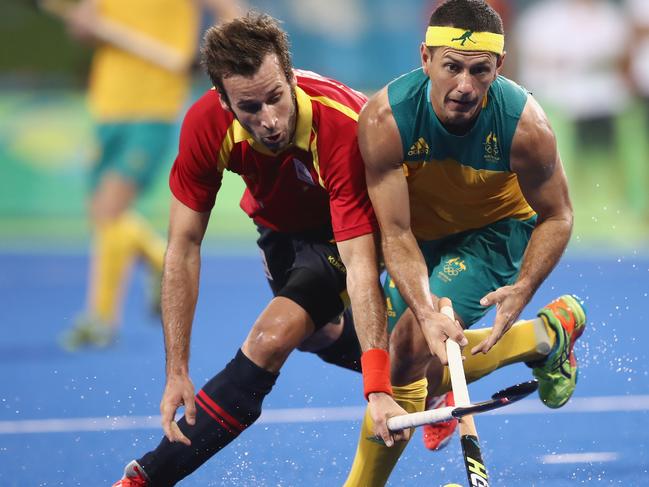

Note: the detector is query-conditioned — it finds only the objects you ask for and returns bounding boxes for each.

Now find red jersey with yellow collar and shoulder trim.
[170,70,377,241]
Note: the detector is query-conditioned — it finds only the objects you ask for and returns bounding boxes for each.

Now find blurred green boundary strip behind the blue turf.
[0,90,649,253]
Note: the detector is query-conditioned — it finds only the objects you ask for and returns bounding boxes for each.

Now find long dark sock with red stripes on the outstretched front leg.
[138,350,279,487]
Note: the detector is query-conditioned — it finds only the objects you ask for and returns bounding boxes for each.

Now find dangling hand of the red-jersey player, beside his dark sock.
[160,374,196,446]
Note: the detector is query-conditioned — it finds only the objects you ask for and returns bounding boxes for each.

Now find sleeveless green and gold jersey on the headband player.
[388,68,535,240]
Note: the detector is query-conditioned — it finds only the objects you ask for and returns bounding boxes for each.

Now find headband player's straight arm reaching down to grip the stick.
[358,88,465,363]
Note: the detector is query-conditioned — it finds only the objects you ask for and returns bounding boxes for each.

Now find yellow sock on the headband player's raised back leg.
[433,318,556,396]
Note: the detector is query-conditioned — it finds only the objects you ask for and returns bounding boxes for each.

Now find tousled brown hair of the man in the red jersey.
[201,12,293,103]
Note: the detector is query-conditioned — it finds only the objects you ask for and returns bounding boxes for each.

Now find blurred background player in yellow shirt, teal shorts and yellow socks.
[59,0,240,350]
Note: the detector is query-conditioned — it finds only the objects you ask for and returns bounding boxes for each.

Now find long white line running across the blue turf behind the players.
[0,395,649,435]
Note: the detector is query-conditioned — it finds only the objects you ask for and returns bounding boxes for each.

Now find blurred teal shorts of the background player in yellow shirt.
[90,121,175,190]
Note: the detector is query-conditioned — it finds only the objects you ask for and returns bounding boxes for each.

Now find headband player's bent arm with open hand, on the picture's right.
[472,96,573,353]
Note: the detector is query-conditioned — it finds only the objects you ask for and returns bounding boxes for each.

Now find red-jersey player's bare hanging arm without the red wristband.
[160,197,209,444]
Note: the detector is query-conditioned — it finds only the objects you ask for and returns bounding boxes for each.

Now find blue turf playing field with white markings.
[0,253,649,487]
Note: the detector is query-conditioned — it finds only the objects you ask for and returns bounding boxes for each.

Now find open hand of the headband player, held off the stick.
[471,285,530,355]
